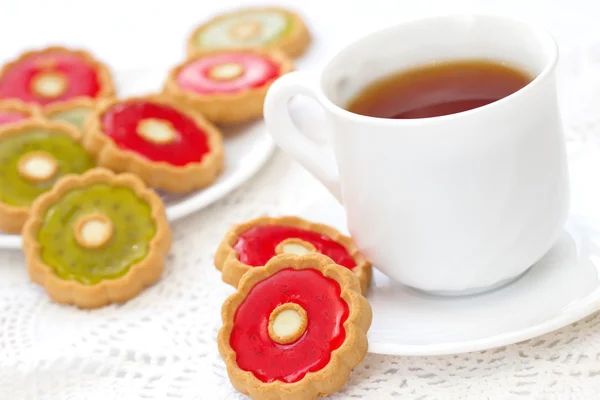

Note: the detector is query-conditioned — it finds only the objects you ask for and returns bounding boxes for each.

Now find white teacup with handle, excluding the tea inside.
[265,16,568,294]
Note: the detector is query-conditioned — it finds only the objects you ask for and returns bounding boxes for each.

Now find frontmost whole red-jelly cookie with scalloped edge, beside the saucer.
[218,253,372,400]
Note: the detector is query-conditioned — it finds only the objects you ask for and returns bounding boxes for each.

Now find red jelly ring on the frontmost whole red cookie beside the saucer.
[230,269,349,383]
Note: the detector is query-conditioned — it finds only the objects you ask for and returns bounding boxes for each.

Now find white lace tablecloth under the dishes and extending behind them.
[0,0,600,400]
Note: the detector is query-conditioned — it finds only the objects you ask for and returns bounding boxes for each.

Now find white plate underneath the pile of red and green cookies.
[0,69,275,249]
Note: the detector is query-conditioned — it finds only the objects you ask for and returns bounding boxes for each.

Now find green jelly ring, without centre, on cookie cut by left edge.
[0,130,94,207]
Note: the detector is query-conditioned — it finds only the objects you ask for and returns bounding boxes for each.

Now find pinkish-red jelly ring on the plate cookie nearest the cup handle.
[176,52,280,94]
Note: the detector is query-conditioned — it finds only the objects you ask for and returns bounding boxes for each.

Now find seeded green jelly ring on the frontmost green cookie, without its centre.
[37,184,156,285]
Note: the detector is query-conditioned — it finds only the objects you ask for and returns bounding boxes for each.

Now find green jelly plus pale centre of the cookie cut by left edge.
[0,128,94,207]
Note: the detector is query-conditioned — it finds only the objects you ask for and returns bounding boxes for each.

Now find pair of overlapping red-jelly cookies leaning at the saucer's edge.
[215,216,372,400]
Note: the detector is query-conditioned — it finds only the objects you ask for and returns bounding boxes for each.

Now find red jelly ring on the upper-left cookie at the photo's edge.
[0,51,100,105]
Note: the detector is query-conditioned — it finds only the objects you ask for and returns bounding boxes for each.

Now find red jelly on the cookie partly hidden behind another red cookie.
[234,225,356,269]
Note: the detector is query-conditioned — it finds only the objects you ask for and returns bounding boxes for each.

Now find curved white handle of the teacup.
[264,72,342,203]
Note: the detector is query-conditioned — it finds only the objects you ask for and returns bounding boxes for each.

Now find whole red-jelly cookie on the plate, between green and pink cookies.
[83,96,224,193]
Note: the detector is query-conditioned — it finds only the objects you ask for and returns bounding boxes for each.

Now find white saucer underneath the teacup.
[301,192,600,355]
